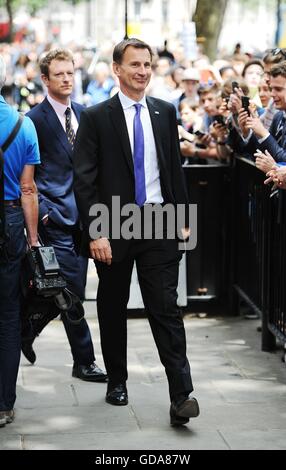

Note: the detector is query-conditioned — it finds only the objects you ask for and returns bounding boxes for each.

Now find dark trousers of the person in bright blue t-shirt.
[0,207,26,411]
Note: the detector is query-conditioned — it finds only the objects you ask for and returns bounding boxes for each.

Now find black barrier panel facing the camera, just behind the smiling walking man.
[183,162,232,313]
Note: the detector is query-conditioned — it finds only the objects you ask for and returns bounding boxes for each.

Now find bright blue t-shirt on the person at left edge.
[0,95,41,201]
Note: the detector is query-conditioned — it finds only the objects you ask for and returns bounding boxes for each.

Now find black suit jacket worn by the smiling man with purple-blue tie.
[74,95,188,260]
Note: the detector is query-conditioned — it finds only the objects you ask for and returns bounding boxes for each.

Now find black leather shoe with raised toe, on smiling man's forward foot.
[170,396,200,426]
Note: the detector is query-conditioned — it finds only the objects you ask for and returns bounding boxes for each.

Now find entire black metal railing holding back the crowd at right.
[184,157,286,351]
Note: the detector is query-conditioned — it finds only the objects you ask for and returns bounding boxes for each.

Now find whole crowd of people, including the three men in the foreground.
[0,35,286,427]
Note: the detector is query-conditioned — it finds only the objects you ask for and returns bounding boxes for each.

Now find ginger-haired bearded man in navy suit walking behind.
[22,49,107,382]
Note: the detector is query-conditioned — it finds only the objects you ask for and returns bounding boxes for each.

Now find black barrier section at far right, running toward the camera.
[232,157,286,351]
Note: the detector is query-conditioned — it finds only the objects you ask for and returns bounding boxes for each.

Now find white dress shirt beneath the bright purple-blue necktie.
[118,90,163,204]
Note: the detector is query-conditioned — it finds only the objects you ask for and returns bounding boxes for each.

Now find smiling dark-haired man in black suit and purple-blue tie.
[74,39,199,425]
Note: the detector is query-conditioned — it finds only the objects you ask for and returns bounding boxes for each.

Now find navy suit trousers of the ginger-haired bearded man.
[39,220,95,365]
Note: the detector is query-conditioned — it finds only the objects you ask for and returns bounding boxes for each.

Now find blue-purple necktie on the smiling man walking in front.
[133,103,146,207]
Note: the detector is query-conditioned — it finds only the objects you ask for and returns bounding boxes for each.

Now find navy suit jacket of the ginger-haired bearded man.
[27,98,84,226]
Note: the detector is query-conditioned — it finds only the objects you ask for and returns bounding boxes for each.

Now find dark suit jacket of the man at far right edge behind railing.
[244,111,286,162]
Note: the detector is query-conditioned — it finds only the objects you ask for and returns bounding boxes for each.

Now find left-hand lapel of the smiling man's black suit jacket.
[108,95,134,175]
